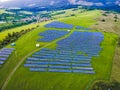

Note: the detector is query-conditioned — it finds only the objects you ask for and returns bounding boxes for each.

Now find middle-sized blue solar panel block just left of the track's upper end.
[37,30,68,42]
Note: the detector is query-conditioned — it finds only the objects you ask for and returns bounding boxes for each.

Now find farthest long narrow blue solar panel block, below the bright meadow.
[45,21,73,29]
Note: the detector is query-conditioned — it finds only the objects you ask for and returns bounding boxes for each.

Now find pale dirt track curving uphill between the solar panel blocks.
[1,29,74,90]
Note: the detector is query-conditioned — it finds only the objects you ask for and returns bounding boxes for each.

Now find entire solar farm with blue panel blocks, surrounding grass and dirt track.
[0,10,117,90]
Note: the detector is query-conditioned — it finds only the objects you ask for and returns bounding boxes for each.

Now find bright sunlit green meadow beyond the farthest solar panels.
[59,10,101,27]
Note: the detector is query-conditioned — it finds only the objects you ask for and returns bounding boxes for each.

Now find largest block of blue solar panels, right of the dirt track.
[24,31,104,74]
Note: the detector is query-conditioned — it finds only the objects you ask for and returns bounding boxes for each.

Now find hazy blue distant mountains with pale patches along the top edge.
[0,0,120,9]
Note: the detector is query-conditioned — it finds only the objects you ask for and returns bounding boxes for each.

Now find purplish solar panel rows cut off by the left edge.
[0,48,14,65]
